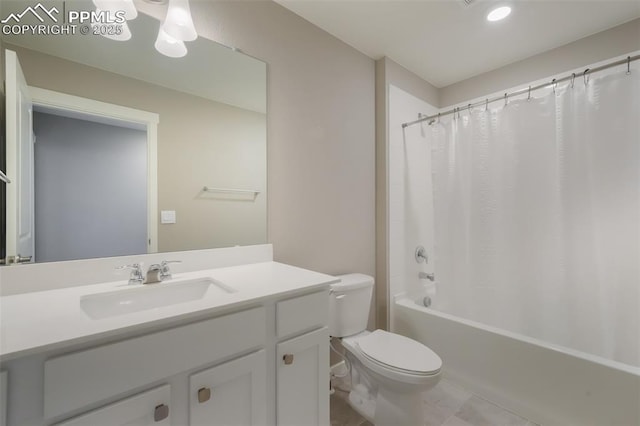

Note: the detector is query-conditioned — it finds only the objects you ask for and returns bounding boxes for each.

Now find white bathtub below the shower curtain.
[391,297,640,426]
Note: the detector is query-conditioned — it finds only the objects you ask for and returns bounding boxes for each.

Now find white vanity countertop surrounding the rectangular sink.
[0,262,339,361]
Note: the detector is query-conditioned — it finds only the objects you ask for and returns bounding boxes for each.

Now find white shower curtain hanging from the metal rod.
[429,66,640,366]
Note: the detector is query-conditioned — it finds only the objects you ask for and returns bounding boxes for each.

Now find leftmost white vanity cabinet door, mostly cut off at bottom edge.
[57,385,171,426]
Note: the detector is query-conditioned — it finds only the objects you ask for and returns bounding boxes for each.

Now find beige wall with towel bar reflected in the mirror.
[7,45,267,251]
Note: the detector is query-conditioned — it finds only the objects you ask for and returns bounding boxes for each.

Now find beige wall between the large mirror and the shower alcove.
[182,0,375,282]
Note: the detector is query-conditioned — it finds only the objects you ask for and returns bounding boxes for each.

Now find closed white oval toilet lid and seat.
[354,330,442,376]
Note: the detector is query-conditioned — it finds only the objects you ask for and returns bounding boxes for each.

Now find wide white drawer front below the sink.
[44,308,266,418]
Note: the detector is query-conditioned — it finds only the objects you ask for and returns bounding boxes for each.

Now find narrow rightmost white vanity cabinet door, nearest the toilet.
[276,327,329,426]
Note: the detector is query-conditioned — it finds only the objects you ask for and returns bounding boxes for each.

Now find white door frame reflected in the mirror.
[29,86,160,253]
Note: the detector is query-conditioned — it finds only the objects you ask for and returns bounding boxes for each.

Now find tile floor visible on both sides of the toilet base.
[331,379,537,426]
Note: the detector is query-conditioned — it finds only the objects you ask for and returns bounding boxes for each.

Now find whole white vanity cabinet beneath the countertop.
[0,287,329,426]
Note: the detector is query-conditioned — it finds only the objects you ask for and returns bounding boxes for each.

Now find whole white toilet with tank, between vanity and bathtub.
[329,274,442,426]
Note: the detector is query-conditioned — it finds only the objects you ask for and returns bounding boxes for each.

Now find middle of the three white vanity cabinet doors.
[189,350,267,426]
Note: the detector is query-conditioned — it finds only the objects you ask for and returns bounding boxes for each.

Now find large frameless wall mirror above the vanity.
[0,0,267,263]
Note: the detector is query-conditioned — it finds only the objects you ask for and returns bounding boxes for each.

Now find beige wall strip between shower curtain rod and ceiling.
[440,19,640,108]
